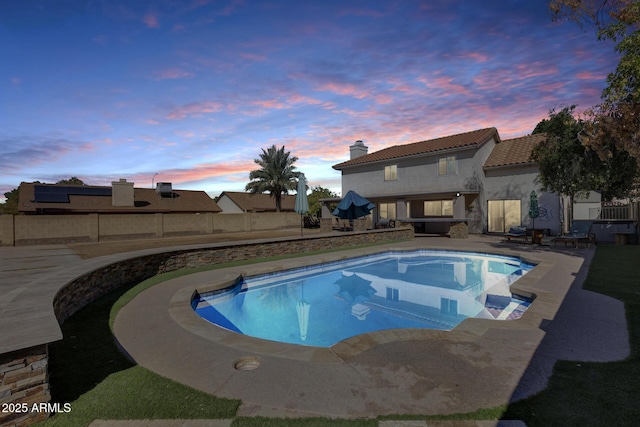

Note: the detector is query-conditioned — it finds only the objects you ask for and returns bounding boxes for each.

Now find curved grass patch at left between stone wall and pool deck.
[41,282,240,427]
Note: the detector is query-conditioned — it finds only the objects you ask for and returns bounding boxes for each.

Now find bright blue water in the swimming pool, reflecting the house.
[193,250,533,347]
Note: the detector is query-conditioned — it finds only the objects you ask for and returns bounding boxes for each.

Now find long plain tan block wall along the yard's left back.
[0,212,300,246]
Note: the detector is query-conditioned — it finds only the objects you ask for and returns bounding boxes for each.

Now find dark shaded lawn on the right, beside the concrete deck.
[503,245,640,427]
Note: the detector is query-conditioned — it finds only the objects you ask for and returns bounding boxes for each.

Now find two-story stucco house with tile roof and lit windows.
[333,128,560,234]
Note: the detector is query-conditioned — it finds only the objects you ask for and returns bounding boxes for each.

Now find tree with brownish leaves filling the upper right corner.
[549,0,640,164]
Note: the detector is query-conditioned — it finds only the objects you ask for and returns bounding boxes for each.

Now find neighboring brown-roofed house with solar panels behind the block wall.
[18,179,221,215]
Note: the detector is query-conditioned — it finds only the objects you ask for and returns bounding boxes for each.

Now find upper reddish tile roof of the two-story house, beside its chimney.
[333,127,500,170]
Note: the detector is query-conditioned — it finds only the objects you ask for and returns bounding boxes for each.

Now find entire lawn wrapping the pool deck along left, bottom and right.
[43,245,640,427]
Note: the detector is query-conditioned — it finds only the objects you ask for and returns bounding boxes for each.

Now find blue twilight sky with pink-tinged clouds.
[0,0,617,201]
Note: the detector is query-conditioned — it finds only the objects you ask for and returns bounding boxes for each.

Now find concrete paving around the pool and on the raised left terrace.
[0,230,629,425]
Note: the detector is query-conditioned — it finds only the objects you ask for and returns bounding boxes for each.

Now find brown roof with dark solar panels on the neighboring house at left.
[18,182,222,213]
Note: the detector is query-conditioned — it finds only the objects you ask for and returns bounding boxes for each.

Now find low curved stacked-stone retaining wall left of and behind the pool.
[0,226,414,426]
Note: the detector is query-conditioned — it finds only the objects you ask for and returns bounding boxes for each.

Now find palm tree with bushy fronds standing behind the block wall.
[245,145,300,212]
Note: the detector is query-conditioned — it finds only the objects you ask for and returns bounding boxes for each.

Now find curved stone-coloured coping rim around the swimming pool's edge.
[168,245,552,363]
